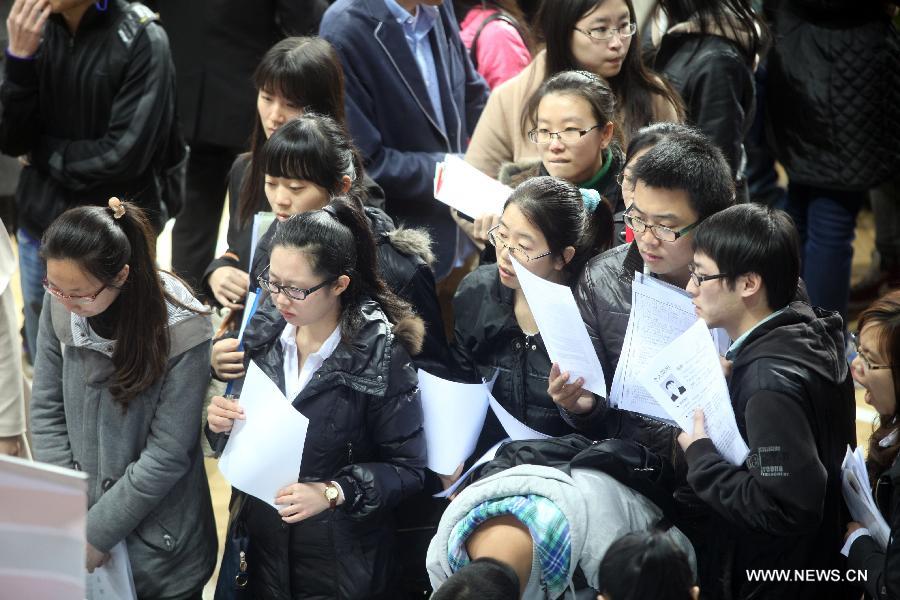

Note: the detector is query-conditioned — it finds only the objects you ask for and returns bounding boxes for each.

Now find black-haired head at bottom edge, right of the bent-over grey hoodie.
[598,531,694,600]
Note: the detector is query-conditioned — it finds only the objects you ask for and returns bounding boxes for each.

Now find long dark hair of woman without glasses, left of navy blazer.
[238,37,346,224]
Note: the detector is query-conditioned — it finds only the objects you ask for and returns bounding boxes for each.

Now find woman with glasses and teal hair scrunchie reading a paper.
[451,177,612,482]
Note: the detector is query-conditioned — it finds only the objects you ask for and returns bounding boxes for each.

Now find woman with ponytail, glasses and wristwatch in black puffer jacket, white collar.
[207,198,425,599]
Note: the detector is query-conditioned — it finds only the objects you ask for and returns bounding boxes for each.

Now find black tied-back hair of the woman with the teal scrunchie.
[503,176,613,285]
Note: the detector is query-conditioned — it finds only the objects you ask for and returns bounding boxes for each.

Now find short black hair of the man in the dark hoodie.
[694,204,800,310]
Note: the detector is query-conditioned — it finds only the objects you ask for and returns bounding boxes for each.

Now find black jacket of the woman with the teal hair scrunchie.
[451,264,603,457]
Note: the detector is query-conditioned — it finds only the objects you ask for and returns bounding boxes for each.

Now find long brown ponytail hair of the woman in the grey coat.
[41,202,194,405]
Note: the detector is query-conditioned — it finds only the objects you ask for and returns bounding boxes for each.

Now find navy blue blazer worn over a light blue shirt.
[319,0,488,279]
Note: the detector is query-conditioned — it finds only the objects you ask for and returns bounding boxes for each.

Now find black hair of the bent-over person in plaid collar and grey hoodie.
[431,558,519,600]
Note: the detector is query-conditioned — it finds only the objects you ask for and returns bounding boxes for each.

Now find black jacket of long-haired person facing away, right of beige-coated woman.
[654,12,756,179]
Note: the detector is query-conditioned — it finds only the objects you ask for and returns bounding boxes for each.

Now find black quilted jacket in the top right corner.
[766,0,900,190]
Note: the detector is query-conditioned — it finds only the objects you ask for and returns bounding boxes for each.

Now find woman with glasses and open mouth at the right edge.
[844,291,900,600]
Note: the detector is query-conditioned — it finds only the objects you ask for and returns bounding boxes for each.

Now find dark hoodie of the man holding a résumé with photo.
[685,302,858,600]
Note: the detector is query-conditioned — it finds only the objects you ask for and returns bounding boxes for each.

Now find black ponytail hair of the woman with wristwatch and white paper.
[272,197,415,346]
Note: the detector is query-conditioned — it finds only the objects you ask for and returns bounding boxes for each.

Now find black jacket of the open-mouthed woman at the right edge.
[847,458,900,600]
